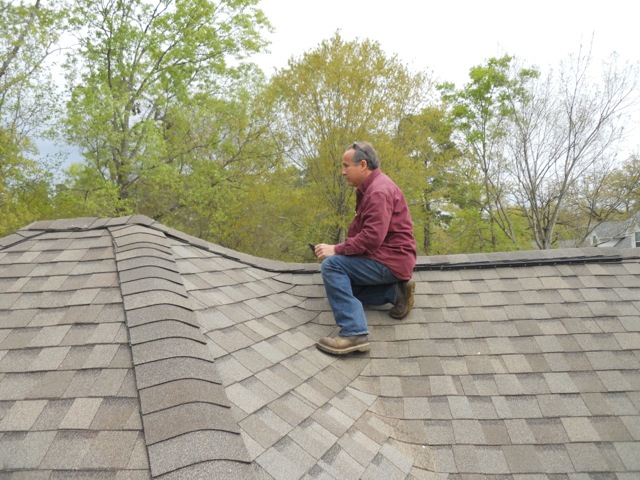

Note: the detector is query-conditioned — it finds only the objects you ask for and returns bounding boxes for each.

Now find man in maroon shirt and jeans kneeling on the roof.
[314,142,416,355]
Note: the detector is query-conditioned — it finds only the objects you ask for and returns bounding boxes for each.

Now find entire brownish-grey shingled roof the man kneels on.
[0,216,640,480]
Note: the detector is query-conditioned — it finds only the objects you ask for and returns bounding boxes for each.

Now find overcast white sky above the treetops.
[254,0,640,149]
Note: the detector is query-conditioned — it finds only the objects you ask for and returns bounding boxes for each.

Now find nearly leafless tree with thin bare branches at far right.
[508,50,638,249]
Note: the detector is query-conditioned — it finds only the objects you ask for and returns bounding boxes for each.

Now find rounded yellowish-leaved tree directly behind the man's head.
[272,33,427,243]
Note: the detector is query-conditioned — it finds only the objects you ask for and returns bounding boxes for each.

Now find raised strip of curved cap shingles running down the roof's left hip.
[107,220,250,477]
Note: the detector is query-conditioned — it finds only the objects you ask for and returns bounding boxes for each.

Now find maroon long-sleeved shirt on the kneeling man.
[335,168,416,280]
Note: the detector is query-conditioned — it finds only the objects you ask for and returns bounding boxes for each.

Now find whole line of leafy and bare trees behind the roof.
[0,0,640,262]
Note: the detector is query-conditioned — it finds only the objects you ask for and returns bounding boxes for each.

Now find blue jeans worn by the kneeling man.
[320,255,400,337]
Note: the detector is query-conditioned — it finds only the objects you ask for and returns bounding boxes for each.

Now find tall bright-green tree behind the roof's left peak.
[66,0,268,216]
